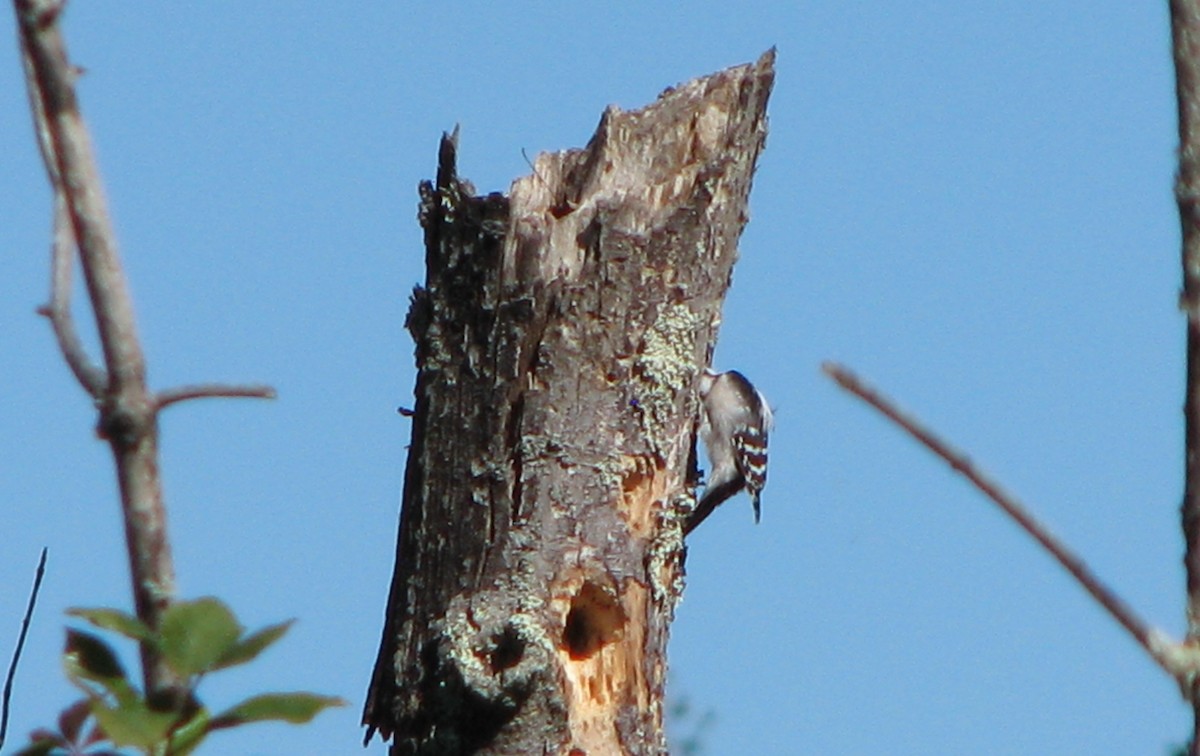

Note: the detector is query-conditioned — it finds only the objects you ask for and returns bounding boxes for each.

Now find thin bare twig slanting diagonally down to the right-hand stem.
[821,362,1183,679]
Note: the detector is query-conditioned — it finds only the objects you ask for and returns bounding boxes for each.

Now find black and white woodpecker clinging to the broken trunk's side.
[683,370,774,535]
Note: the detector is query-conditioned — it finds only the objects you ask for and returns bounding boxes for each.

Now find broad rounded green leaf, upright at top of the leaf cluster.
[158,598,242,677]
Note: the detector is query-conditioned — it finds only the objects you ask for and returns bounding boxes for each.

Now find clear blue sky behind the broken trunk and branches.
[0,0,1190,754]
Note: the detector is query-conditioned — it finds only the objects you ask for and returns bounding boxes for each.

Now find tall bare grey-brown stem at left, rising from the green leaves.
[13,0,179,694]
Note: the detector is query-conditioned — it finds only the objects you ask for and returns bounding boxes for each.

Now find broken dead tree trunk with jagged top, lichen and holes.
[364,52,774,754]
